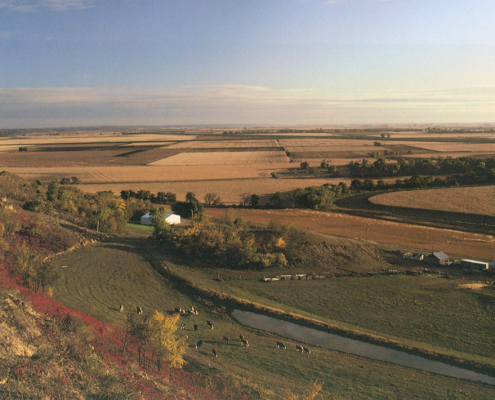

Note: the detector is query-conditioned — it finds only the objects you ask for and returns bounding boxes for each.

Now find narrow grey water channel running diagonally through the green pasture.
[232,310,495,385]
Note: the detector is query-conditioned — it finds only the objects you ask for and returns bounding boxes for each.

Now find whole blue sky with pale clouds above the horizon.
[0,0,495,129]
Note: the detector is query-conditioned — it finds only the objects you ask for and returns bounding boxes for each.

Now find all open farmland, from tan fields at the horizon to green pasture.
[4,124,495,399]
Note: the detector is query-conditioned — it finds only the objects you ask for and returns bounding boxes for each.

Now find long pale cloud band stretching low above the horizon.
[0,85,495,127]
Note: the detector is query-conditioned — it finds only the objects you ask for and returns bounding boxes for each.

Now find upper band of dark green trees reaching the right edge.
[346,157,495,178]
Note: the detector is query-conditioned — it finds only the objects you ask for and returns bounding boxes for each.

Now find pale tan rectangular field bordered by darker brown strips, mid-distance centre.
[149,151,289,166]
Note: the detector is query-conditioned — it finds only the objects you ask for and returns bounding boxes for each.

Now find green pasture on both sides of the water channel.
[54,237,494,399]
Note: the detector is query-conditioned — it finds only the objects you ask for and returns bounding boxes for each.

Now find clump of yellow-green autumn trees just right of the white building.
[153,210,288,269]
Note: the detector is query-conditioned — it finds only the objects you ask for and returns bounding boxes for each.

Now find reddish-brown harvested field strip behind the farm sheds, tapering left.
[206,209,495,260]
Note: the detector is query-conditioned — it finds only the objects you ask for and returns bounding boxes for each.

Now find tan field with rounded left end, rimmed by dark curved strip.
[369,186,495,216]
